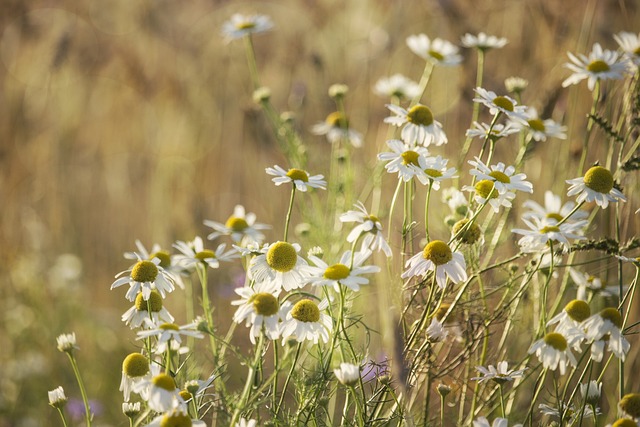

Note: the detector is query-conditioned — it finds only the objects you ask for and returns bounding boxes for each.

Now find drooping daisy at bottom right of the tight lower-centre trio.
[280,299,333,345]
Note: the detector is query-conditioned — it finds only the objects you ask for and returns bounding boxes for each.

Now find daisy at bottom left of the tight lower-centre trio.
[231,281,283,344]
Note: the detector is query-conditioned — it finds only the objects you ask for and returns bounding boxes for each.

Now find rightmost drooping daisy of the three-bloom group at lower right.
[582,307,631,362]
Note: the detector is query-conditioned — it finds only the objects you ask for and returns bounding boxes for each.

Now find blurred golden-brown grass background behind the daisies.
[0,0,640,427]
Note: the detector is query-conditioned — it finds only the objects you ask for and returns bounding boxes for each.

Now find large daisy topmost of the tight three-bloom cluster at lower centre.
[249,242,309,292]
